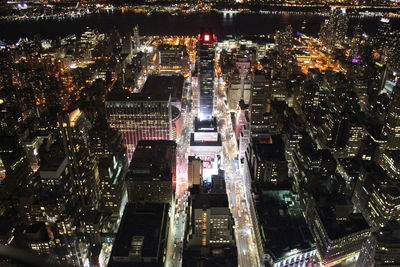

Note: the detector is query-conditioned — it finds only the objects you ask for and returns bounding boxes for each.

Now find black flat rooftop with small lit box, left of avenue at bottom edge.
[107,203,169,267]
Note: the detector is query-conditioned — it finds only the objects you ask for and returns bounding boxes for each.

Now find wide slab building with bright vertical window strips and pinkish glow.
[106,76,183,160]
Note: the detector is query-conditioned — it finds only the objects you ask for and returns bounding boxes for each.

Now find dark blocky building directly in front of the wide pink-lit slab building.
[126,140,176,203]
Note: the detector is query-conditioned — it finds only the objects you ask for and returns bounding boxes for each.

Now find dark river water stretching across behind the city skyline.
[0,11,400,42]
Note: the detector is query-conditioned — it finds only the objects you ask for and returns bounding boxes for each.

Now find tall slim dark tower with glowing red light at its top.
[197,30,216,120]
